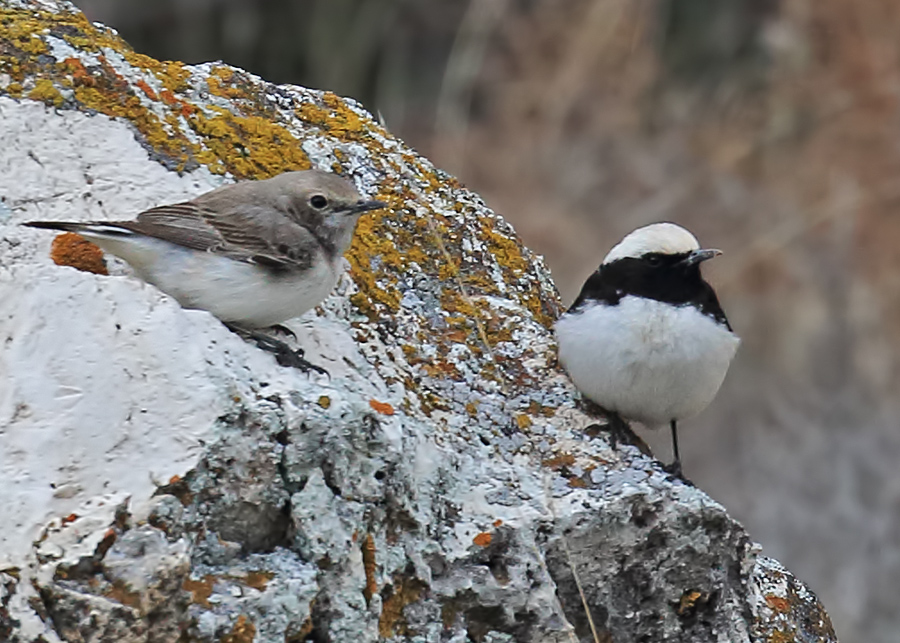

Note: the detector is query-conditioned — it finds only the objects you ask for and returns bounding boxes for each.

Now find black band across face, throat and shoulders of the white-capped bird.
[568,253,731,330]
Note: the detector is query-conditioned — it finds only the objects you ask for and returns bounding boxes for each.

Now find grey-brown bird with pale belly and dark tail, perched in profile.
[25,170,385,370]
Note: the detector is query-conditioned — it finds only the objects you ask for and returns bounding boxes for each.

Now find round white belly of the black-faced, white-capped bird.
[556,296,740,427]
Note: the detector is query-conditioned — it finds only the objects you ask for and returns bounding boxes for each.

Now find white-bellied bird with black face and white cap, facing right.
[556,223,740,475]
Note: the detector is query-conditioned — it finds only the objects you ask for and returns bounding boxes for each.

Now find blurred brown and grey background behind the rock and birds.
[75,0,900,643]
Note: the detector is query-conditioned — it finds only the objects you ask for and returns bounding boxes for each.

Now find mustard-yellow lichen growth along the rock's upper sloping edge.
[0,1,554,423]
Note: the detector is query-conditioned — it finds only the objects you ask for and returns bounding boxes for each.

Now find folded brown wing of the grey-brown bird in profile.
[132,202,316,269]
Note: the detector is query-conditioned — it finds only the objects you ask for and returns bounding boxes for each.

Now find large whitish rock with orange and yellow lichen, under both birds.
[0,0,835,643]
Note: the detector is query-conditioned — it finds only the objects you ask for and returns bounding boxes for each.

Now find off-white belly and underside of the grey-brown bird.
[85,234,342,328]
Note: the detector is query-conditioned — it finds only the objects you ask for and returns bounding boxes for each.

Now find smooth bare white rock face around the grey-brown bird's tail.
[0,97,338,564]
